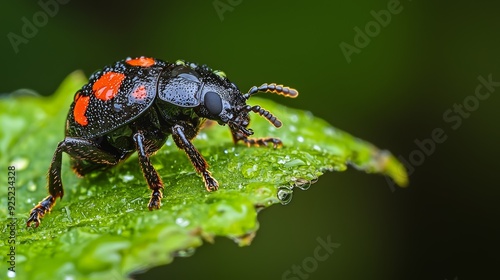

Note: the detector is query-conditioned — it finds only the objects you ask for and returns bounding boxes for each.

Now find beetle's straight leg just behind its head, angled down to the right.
[172,125,219,192]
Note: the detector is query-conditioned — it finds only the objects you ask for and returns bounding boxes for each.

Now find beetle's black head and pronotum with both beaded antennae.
[166,61,298,136]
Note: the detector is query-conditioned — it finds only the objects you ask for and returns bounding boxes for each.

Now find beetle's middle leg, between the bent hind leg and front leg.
[134,132,163,210]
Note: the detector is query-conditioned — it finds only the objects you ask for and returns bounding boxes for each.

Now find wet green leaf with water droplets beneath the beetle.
[0,72,408,279]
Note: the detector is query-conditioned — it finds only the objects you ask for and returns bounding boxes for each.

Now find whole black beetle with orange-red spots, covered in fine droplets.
[27,57,298,227]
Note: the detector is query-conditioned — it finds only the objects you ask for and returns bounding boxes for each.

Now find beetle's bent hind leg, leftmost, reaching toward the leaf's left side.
[26,137,117,227]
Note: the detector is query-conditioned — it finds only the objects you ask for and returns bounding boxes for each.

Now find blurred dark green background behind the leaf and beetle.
[0,0,500,280]
